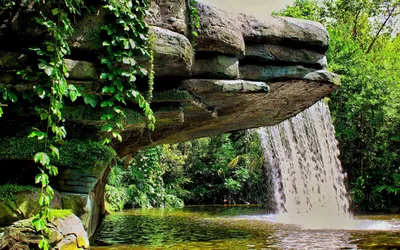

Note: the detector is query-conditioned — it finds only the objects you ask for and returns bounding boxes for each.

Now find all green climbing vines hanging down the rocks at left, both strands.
[0,0,155,249]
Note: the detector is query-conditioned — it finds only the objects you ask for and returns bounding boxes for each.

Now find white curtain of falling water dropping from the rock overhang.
[258,102,351,220]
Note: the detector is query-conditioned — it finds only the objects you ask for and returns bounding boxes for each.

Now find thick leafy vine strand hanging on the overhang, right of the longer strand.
[100,0,155,144]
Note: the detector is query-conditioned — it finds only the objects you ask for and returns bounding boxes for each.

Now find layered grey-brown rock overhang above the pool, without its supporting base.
[0,0,339,155]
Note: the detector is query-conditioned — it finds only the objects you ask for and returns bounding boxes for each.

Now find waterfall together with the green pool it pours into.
[92,102,400,250]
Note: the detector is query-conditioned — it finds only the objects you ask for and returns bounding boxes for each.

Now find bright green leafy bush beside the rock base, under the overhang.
[106,146,187,211]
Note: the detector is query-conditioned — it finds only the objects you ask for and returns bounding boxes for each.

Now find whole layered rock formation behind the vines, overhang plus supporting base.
[0,0,340,246]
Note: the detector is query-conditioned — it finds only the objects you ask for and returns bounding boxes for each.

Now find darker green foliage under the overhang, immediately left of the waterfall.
[185,131,265,204]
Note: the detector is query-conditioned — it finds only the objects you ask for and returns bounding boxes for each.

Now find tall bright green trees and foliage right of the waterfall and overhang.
[277,0,400,212]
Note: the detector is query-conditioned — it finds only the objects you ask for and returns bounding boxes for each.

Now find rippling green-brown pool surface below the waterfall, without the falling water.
[91,206,400,250]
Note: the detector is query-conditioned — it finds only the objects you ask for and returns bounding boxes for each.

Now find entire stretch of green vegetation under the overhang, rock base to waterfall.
[106,131,267,210]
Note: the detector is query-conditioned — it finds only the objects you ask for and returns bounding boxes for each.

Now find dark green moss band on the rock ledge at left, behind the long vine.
[0,138,116,169]
